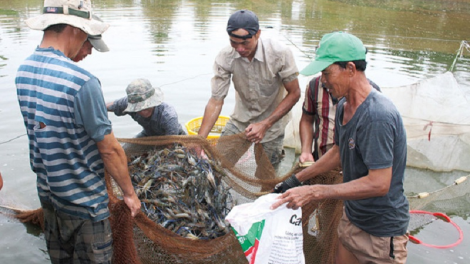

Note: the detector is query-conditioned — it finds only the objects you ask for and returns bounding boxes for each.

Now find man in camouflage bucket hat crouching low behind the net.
[106,79,186,138]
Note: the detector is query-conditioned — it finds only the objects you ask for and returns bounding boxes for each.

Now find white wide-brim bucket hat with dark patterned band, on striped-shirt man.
[26,0,109,36]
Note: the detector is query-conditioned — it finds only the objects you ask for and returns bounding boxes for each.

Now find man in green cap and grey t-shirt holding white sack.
[272,32,410,264]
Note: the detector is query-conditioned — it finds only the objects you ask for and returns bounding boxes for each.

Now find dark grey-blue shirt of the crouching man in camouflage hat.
[110,97,186,137]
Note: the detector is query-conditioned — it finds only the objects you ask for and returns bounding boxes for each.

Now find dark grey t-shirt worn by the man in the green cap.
[335,89,410,237]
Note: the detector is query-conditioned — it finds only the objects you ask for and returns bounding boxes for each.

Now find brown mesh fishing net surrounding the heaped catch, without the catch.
[1,134,342,264]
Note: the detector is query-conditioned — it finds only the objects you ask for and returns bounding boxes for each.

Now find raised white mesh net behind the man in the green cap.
[382,72,470,172]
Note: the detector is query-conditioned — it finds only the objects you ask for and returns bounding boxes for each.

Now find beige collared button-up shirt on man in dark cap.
[211,38,298,142]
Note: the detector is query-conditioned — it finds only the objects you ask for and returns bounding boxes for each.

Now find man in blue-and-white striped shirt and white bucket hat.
[15,0,140,263]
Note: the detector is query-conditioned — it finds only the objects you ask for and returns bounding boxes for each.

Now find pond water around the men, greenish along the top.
[0,0,470,263]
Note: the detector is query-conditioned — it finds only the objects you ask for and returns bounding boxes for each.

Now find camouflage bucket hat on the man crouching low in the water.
[124,79,163,112]
